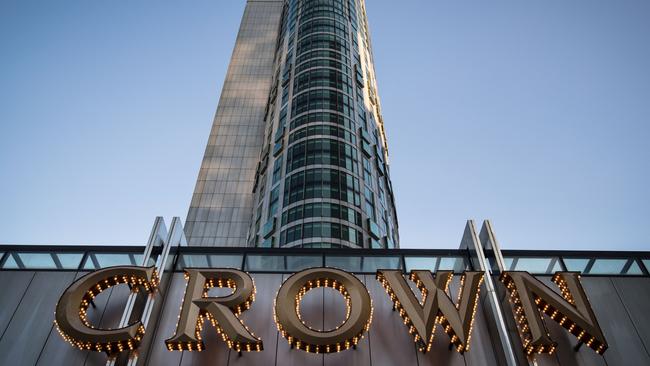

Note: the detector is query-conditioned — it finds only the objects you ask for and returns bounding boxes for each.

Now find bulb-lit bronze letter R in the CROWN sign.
[165,268,262,352]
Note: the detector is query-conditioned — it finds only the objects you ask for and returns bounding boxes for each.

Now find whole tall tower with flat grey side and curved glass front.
[186,0,399,248]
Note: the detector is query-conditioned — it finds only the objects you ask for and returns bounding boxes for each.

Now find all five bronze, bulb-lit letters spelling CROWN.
[55,266,607,356]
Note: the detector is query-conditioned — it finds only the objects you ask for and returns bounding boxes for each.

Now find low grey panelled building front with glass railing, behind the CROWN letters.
[0,220,650,366]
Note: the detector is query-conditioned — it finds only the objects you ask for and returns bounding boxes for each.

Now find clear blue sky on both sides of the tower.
[0,0,650,250]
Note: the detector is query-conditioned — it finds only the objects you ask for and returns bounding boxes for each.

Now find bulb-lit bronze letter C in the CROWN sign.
[54,266,158,354]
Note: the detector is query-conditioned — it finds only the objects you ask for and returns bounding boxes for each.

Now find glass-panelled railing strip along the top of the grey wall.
[0,245,650,276]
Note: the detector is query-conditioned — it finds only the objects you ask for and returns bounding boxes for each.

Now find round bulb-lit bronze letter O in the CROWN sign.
[273,268,372,353]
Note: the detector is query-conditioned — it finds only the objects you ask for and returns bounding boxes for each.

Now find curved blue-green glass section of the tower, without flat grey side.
[247,0,399,248]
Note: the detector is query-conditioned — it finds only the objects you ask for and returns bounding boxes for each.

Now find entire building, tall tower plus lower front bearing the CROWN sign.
[0,0,650,366]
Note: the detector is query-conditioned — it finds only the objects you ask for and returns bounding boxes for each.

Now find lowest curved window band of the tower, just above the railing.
[280,222,363,246]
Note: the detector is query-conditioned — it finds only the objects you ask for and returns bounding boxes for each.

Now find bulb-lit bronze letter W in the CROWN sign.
[377,270,483,353]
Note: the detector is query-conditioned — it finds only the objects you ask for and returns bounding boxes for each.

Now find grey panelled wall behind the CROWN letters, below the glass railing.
[0,271,650,366]
